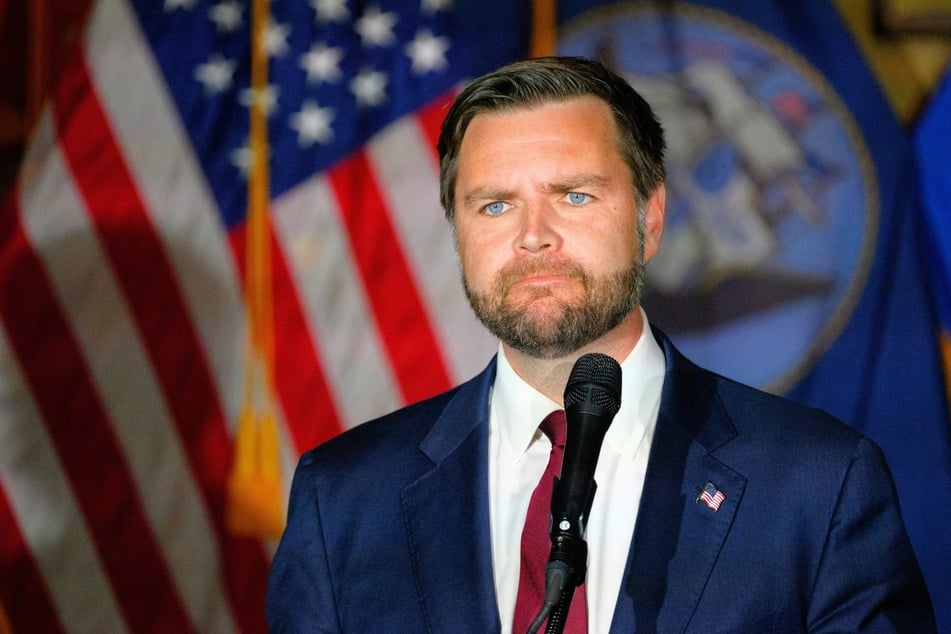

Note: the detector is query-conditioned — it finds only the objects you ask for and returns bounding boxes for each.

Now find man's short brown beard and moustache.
[463,250,644,359]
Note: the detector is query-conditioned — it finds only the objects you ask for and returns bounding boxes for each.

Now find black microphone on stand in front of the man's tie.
[530,352,621,631]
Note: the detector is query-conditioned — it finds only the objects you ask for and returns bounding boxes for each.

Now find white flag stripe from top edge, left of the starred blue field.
[87,0,246,429]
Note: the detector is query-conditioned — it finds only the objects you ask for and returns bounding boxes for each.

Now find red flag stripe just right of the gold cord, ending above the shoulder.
[231,225,342,453]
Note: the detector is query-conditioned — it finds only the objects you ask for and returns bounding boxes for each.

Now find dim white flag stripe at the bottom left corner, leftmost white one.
[0,324,125,632]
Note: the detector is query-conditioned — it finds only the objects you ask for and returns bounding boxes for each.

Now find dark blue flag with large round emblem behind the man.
[559,0,951,628]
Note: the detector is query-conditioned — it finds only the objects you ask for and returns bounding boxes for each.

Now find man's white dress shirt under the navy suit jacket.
[489,311,666,634]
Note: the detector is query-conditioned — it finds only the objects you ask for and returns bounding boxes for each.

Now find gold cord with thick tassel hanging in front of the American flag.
[227,0,285,537]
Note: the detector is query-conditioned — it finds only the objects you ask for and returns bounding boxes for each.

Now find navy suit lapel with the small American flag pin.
[611,332,746,632]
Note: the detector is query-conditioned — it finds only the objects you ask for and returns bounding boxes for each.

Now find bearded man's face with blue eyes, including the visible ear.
[455,98,664,358]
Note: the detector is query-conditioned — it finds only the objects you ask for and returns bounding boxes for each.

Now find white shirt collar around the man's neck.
[490,308,666,461]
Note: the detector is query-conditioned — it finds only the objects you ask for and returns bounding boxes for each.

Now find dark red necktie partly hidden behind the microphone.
[512,410,588,634]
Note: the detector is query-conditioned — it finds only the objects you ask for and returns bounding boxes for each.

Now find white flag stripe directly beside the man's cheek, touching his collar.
[368,117,498,381]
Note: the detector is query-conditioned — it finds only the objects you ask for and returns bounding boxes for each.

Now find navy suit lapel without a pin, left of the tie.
[402,363,499,633]
